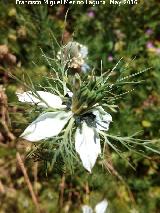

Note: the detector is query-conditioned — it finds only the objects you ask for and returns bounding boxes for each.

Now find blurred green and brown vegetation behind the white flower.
[0,0,160,213]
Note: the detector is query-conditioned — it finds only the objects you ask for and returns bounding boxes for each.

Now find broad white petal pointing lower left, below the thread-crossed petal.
[20,111,72,142]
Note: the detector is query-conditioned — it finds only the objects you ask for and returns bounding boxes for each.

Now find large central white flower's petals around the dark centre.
[17,91,112,172]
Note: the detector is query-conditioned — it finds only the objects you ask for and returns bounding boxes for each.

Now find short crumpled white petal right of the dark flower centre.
[92,107,112,131]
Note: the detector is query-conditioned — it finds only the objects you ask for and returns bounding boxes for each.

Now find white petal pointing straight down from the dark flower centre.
[75,122,101,172]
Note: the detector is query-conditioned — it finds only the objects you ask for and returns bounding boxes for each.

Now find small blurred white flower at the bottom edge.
[82,199,108,213]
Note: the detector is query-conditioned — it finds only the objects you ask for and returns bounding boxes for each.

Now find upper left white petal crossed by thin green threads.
[16,91,65,108]
